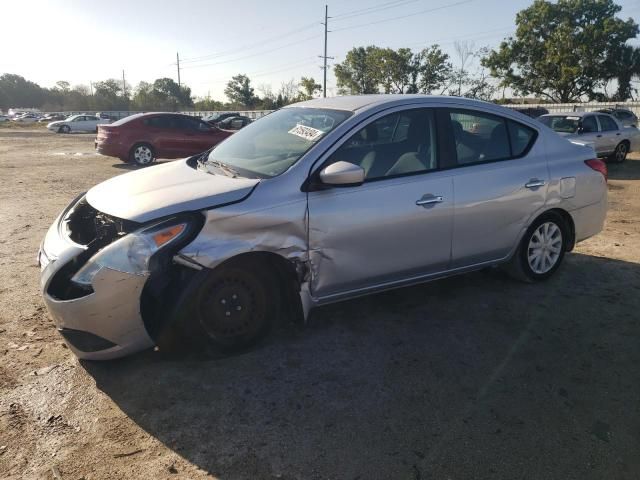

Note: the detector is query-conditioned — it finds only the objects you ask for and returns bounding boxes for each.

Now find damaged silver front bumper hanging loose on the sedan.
[38,197,154,360]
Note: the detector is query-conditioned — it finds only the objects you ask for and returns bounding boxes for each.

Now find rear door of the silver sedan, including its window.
[447,109,549,268]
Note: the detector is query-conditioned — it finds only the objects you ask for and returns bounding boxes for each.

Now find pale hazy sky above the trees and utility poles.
[0,0,640,101]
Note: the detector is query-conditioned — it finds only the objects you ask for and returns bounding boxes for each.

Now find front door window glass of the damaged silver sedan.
[329,109,438,181]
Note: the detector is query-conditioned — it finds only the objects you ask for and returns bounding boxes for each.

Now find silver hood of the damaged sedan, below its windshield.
[87,160,260,222]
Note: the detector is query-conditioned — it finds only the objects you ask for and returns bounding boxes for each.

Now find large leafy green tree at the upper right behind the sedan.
[482,0,638,102]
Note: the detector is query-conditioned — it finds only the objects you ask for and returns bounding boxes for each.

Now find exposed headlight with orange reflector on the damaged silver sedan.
[71,222,190,286]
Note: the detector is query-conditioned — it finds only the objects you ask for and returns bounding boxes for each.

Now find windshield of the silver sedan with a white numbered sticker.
[207,107,352,178]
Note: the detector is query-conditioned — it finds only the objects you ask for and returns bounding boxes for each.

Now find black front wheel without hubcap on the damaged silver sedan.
[181,263,278,354]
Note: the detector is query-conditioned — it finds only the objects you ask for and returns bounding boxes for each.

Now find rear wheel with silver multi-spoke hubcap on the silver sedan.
[506,212,569,283]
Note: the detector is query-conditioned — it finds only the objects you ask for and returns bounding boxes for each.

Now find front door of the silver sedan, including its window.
[308,108,453,298]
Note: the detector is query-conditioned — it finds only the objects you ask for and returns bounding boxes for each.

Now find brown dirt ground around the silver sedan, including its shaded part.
[0,127,640,480]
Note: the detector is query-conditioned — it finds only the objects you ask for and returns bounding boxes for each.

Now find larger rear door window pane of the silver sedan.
[449,111,511,165]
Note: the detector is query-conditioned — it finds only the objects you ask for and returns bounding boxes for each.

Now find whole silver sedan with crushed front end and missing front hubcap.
[39,95,607,360]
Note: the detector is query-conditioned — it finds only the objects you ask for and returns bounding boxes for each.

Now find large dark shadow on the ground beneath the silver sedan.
[83,253,640,479]
